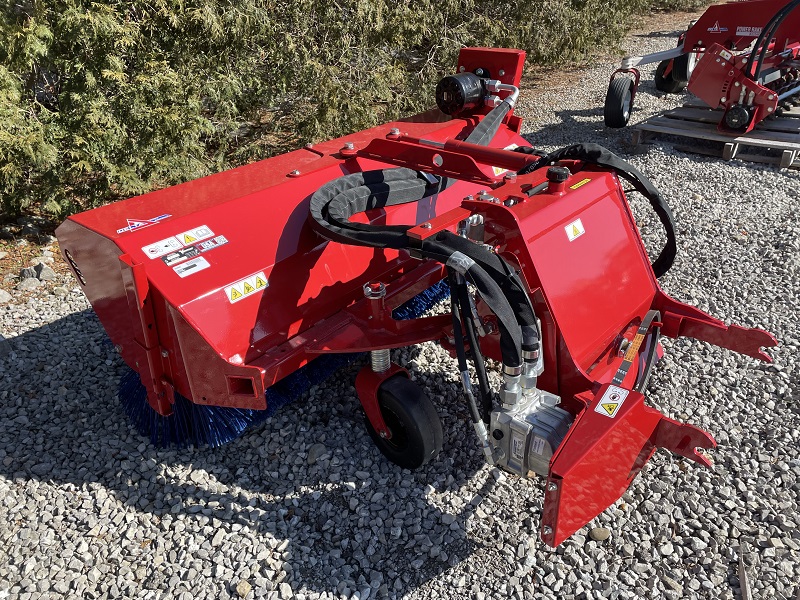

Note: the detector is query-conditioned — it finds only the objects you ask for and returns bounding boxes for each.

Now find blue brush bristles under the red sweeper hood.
[119,280,450,447]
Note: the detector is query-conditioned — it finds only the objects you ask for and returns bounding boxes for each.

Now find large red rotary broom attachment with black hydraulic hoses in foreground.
[58,49,776,546]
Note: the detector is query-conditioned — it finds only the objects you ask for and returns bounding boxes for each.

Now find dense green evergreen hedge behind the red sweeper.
[0,0,703,217]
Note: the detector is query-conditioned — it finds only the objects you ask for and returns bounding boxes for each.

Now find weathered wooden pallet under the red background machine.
[632,103,800,169]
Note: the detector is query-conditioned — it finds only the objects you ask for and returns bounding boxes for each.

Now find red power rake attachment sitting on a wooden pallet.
[603,0,800,135]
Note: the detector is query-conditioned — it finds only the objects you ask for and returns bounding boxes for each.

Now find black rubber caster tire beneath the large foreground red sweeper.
[365,375,444,470]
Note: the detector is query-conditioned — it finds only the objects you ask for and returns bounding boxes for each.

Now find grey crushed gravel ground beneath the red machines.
[0,12,800,600]
